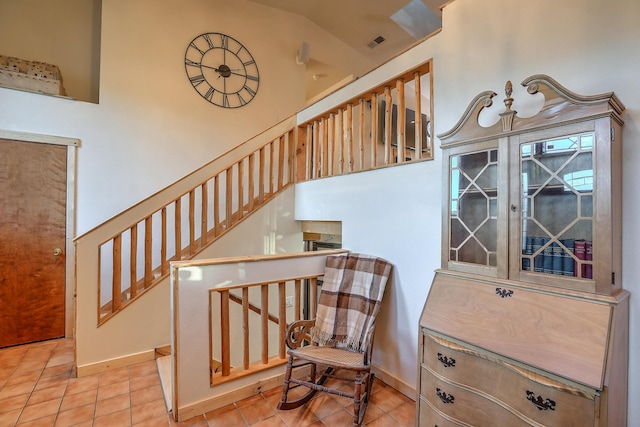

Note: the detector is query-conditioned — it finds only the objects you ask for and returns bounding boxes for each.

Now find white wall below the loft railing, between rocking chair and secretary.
[296,160,441,392]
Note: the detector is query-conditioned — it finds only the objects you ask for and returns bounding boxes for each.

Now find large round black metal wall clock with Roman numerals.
[184,33,260,108]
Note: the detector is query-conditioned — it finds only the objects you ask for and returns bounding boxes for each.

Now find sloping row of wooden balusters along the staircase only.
[93,123,295,325]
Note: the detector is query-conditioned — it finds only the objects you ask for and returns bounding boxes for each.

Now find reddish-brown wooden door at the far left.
[0,139,67,347]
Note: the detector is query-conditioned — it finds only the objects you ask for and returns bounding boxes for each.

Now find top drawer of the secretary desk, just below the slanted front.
[422,335,596,426]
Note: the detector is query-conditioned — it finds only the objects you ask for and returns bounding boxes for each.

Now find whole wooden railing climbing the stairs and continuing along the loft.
[76,62,433,325]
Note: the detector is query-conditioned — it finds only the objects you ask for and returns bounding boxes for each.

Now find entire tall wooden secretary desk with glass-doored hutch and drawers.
[417,75,629,427]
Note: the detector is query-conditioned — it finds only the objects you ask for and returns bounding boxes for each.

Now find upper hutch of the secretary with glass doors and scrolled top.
[440,76,624,295]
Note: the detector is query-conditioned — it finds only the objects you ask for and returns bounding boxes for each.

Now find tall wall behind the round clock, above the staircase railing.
[0,0,367,235]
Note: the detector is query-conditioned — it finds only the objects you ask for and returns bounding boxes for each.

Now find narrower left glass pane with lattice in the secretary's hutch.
[449,148,498,267]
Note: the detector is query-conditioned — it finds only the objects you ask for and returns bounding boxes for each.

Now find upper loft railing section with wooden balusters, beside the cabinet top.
[296,61,433,181]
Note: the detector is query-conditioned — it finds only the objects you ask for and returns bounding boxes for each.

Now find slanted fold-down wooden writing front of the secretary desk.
[421,273,611,389]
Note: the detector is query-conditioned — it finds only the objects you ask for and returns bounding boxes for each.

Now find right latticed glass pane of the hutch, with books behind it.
[520,133,594,279]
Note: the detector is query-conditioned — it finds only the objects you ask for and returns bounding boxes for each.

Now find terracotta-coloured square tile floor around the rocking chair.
[0,339,415,427]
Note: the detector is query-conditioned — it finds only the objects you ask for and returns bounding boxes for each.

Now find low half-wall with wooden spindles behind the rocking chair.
[171,250,346,421]
